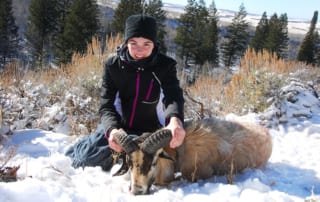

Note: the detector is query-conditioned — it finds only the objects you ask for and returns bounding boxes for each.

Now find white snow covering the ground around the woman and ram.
[0,80,320,202]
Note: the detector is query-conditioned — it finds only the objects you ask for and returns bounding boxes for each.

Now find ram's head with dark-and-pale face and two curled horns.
[114,129,172,195]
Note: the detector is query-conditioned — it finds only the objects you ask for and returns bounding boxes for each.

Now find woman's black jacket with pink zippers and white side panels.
[99,47,184,135]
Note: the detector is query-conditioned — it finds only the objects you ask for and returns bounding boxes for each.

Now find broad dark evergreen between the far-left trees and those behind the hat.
[59,0,99,63]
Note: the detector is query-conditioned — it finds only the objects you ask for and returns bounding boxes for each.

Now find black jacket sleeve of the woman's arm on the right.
[161,59,184,124]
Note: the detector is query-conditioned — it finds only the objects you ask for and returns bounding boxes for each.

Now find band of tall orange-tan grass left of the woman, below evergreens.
[0,35,121,89]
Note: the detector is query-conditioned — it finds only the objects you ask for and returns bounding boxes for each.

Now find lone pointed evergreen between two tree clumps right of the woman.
[222,4,250,67]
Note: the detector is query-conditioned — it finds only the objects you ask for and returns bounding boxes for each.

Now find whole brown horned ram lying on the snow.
[114,118,272,194]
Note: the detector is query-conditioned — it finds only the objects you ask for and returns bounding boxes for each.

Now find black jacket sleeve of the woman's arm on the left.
[99,58,121,134]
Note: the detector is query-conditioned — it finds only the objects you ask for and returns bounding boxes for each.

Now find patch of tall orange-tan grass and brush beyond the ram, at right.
[224,49,319,114]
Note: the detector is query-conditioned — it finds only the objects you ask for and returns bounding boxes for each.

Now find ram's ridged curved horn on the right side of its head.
[141,129,172,154]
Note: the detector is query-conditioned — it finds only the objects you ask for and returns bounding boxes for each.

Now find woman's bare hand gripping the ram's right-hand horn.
[165,117,186,148]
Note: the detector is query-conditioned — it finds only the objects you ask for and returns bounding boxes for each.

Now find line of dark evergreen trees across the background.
[0,0,320,68]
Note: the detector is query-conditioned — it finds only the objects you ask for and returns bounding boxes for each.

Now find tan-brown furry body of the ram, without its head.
[155,118,272,184]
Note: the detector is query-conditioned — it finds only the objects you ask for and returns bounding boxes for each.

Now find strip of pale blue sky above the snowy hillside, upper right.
[163,0,320,21]
